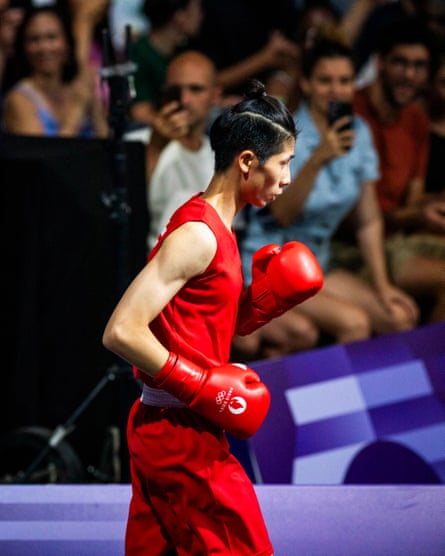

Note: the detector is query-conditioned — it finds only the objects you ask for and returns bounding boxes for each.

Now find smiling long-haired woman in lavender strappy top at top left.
[3,6,108,137]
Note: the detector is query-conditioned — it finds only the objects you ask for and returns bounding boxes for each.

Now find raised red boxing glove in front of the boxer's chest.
[236,241,323,336]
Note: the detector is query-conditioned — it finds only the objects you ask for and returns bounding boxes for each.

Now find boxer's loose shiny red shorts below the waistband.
[125,400,273,556]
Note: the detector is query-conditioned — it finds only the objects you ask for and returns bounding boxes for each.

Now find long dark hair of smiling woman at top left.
[11,6,78,83]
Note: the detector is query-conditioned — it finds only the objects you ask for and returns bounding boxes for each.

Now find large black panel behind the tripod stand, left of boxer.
[0,136,149,480]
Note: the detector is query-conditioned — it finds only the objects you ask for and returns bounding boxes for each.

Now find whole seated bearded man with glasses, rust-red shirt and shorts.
[348,19,445,321]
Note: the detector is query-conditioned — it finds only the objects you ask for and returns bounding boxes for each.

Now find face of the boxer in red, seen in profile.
[241,139,295,207]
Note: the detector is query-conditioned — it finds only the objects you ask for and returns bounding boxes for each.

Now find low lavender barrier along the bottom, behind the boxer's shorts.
[0,485,445,556]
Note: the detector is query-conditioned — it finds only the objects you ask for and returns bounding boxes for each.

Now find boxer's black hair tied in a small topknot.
[210,79,297,172]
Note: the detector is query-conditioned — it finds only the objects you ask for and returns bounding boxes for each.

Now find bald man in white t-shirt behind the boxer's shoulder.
[147,51,220,250]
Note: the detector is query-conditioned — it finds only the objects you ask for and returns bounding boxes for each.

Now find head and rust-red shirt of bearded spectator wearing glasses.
[355,21,430,211]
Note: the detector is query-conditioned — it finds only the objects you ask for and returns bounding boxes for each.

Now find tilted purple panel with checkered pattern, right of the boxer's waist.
[250,322,445,484]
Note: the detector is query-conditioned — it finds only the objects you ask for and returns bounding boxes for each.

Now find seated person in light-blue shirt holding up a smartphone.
[241,38,418,342]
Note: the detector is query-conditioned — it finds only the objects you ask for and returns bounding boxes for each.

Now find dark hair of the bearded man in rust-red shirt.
[376,17,433,56]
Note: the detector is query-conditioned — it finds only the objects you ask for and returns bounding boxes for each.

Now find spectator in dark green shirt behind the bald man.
[130,0,202,125]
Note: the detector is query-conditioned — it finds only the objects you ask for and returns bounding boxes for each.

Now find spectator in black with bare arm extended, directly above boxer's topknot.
[193,0,298,106]
